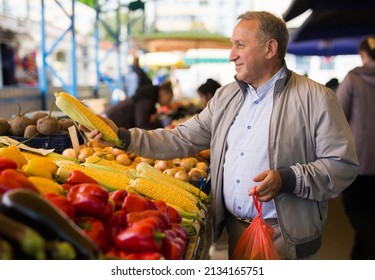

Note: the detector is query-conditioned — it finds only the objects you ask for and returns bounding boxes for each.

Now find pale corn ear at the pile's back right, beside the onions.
[136,162,208,202]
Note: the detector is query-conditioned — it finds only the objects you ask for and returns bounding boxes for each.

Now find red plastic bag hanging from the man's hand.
[231,189,280,260]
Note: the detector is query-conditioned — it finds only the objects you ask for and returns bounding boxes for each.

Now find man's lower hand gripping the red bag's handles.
[249,170,282,202]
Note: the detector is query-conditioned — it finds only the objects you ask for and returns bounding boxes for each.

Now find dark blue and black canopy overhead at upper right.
[283,0,375,56]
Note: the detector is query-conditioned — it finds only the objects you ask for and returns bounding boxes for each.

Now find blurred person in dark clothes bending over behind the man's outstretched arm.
[104,81,173,129]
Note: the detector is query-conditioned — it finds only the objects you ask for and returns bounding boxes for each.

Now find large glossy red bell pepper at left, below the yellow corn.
[67,183,113,219]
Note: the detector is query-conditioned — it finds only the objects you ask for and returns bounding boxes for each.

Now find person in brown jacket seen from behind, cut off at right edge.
[336,36,375,260]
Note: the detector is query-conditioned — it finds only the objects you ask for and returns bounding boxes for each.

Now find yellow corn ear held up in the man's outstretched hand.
[55,92,123,147]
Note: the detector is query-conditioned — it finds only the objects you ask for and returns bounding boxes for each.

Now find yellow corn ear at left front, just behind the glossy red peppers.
[56,164,130,191]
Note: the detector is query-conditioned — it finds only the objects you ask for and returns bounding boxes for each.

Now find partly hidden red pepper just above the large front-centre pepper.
[126,210,171,231]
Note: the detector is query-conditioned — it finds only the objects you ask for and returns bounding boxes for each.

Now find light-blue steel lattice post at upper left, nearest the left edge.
[40,0,77,110]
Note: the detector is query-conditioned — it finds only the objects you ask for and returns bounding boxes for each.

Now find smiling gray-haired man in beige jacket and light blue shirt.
[83,11,360,259]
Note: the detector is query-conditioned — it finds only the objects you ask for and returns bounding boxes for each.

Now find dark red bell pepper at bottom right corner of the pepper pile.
[162,229,187,260]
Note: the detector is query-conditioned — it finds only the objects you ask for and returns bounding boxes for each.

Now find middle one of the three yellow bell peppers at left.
[22,157,58,179]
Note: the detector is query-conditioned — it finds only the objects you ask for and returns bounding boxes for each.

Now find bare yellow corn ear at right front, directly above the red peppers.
[127,177,204,215]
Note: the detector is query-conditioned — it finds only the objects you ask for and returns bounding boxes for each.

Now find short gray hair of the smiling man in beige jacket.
[237,11,289,59]
